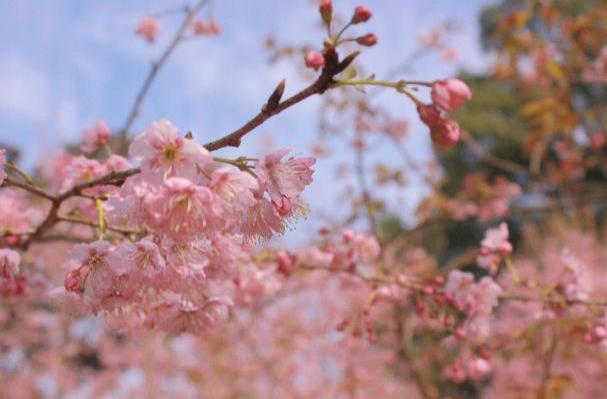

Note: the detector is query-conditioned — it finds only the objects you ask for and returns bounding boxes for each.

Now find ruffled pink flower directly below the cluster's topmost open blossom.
[146,177,226,239]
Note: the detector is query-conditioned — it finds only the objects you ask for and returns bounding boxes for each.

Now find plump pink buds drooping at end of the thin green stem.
[417,79,472,148]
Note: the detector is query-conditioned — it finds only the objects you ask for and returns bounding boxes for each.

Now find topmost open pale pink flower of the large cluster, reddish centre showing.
[129,119,212,183]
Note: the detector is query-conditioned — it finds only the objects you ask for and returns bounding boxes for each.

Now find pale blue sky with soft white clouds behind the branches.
[0,0,492,244]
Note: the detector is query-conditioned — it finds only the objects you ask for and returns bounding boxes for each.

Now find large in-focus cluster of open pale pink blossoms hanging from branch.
[55,120,314,332]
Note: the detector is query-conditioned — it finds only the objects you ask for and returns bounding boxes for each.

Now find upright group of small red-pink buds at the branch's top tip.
[304,0,377,70]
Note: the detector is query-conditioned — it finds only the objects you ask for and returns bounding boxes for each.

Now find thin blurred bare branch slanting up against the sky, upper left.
[119,0,208,150]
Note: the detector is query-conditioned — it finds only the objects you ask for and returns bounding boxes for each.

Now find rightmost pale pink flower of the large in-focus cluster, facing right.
[255,149,316,204]
